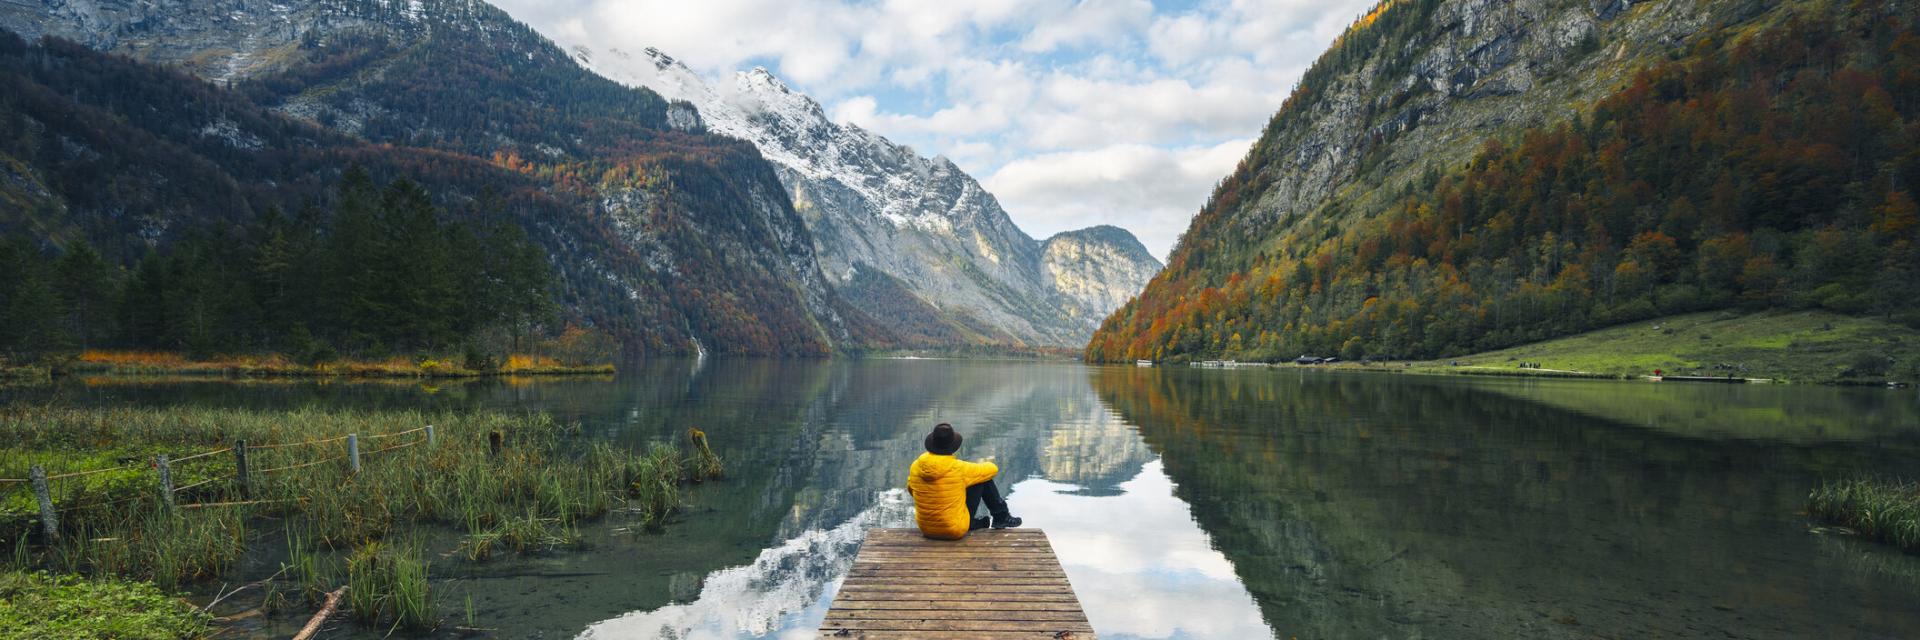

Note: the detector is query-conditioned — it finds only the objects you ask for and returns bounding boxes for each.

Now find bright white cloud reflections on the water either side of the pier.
[580,459,1273,640]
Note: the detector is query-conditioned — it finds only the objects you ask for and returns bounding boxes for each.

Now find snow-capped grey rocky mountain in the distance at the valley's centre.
[572,46,1160,346]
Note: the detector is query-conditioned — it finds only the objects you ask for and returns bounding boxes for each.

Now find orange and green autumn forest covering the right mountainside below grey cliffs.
[1087,10,1920,361]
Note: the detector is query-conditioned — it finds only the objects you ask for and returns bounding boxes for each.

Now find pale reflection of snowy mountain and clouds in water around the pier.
[582,361,1267,638]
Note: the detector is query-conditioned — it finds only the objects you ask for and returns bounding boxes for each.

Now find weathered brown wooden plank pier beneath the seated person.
[820,529,1094,640]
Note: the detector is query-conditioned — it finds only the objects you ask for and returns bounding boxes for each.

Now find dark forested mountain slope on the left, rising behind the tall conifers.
[0,0,893,356]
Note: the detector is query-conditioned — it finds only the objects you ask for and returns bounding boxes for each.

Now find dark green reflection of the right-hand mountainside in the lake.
[1094,369,1920,638]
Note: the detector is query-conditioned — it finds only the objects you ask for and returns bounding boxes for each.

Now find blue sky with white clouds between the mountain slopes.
[493,0,1375,259]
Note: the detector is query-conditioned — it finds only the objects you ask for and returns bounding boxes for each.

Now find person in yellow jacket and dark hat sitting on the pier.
[906,423,1020,540]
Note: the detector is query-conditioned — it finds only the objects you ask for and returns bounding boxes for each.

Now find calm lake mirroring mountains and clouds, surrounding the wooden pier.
[31,359,1920,638]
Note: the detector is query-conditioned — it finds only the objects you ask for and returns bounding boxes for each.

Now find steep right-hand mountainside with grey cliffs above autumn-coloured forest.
[1087,0,1920,359]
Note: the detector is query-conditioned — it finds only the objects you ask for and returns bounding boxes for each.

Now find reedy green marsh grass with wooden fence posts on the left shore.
[0,406,722,638]
